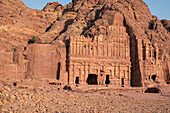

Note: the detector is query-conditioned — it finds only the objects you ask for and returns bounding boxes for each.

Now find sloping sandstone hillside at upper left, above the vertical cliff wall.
[0,0,58,51]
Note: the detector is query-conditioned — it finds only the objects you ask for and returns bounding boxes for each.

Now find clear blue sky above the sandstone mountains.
[22,0,170,20]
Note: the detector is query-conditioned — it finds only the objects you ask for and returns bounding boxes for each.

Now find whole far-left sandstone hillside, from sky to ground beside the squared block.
[0,0,61,79]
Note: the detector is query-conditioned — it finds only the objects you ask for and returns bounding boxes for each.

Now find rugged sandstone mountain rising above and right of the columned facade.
[39,0,170,86]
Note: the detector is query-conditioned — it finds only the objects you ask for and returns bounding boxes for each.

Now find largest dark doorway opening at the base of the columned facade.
[87,74,98,85]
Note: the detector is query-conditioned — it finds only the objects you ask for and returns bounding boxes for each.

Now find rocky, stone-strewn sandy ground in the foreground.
[0,80,170,113]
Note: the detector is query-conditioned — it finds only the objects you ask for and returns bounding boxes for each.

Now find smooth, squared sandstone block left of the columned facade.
[25,42,67,83]
